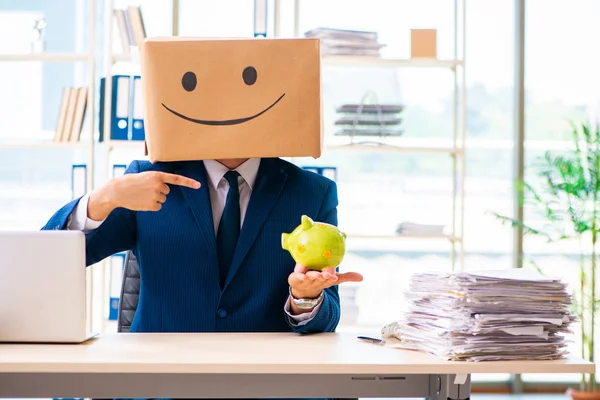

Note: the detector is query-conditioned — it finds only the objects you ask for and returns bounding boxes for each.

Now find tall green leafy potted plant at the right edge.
[495,123,600,399]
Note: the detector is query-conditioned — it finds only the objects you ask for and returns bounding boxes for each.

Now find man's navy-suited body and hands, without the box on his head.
[44,158,362,333]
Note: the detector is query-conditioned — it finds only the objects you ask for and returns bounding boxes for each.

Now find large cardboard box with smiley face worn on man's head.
[140,37,323,162]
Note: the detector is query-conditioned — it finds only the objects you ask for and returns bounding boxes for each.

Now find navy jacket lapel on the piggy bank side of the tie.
[223,158,287,290]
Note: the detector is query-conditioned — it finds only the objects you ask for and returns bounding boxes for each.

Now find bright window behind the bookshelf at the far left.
[0,1,88,230]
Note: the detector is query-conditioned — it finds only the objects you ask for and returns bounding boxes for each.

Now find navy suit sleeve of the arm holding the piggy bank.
[288,181,340,333]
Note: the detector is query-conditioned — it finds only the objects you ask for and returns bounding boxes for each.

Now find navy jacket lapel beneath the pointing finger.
[172,161,219,277]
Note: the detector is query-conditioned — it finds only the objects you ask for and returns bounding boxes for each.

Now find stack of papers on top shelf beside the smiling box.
[304,28,383,56]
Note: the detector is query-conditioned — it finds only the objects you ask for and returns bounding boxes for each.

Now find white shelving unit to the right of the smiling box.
[274,0,466,270]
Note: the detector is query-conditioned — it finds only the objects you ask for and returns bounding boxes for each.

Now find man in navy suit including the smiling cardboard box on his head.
[44,38,362,338]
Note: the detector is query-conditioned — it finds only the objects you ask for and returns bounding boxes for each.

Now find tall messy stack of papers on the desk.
[382,269,575,361]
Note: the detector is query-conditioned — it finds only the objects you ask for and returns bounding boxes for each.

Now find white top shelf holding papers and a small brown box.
[321,55,462,69]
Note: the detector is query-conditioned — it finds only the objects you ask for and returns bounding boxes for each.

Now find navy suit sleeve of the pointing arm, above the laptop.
[42,161,139,266]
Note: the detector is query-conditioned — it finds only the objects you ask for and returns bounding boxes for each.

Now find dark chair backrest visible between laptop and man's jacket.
[117,251,140,332]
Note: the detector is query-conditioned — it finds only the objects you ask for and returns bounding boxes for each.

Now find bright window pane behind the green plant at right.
[523,0,600,382]
